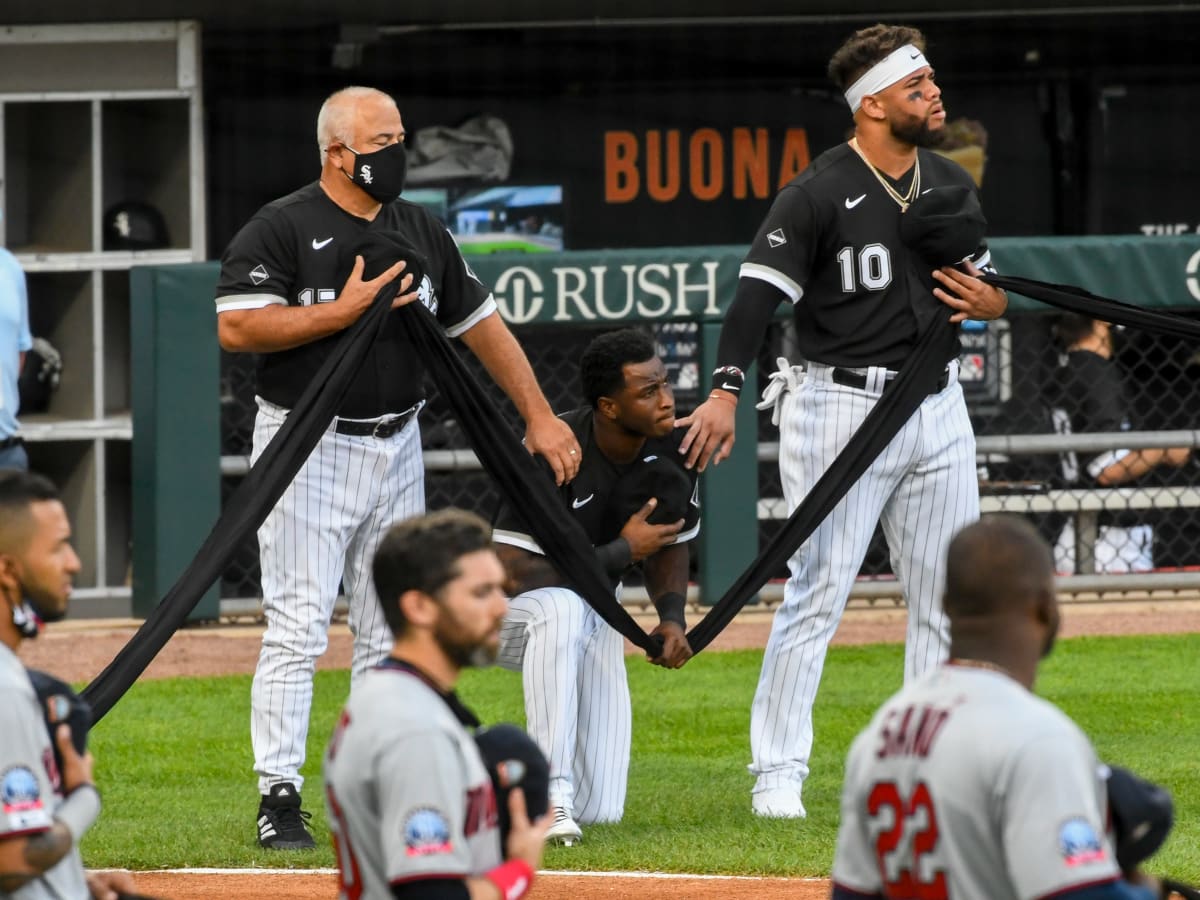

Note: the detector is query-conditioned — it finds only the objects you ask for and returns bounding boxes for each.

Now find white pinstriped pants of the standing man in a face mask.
[250,398,425,794]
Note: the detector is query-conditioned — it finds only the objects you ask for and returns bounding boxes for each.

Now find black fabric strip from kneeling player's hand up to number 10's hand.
[688,317,952,653]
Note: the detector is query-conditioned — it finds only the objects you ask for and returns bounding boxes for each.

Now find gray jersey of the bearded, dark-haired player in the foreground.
[324,661,503,900]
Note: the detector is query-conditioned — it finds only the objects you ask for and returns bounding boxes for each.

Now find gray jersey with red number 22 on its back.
[833,662,1120,900]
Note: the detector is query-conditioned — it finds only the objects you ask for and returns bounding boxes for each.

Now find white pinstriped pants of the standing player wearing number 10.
[750,377,979,791]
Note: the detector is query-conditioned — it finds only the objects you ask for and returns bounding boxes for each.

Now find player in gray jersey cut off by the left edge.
[0,470,144,900]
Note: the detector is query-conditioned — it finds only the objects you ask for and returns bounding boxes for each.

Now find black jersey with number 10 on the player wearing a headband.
[740,144,990,368]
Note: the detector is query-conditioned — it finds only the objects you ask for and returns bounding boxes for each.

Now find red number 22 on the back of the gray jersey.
[866,781,949,900]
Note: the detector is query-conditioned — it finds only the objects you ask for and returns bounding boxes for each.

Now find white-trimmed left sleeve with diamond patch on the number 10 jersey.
[738,185,817,304]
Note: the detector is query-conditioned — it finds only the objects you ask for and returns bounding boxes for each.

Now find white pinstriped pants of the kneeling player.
[499,588,632,824]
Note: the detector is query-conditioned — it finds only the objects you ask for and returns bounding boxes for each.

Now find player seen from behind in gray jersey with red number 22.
[833,516,1159,900]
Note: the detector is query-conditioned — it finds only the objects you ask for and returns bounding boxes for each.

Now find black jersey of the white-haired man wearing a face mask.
[216,182,496,419]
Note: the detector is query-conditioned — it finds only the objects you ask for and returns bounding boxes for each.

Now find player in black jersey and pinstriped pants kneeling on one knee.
[494,329,700,845]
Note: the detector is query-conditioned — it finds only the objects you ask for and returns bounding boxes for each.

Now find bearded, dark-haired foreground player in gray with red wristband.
[324,510,550,900]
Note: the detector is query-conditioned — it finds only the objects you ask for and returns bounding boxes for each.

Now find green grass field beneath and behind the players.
[83,635,1200,882]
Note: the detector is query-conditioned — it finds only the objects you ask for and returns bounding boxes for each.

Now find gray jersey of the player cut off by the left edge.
[0,644,91,900]
